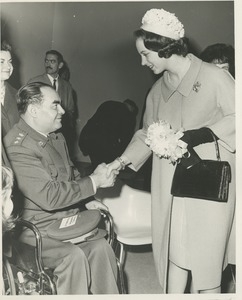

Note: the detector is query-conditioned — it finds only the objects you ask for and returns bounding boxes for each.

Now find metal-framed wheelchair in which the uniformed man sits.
[2,210,114,295]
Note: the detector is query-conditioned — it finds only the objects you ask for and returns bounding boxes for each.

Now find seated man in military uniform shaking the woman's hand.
[4,83,118,295]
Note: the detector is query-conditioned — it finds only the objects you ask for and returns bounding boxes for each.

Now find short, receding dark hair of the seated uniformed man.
[17,82,53,114]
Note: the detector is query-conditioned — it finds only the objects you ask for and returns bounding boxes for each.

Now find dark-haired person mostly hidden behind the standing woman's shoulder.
[200,43,235,77]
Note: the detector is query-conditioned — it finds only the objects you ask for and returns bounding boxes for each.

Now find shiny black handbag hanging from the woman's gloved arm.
[171,130,231,202]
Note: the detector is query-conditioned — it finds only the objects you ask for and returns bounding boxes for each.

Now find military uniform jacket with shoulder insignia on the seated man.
[4,119,94,234]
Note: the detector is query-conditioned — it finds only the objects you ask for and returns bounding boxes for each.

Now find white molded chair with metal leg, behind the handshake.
[95,180,152,294]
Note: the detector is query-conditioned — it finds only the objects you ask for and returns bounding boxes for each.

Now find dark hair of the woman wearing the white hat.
[134,29,188,58]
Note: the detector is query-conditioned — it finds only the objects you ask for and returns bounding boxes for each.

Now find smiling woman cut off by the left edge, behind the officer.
[0,40,19,167]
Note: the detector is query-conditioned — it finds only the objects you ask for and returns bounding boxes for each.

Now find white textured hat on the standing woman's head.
[141,8,185,40]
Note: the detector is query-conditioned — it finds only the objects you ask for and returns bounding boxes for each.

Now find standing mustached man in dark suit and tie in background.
[29,50,76,157]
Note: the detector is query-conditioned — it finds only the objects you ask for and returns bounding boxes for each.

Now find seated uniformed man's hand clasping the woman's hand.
[91,163,119,188]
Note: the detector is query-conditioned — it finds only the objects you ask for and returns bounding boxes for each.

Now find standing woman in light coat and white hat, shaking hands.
[109,9,235,293]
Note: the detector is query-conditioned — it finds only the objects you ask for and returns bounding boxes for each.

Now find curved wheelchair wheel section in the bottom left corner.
[2,257,17,295]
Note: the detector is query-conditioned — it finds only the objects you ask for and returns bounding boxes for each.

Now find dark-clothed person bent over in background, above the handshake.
[79,99,138,168]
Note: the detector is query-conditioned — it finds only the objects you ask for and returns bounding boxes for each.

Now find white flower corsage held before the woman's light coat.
[145,120,188,164]
